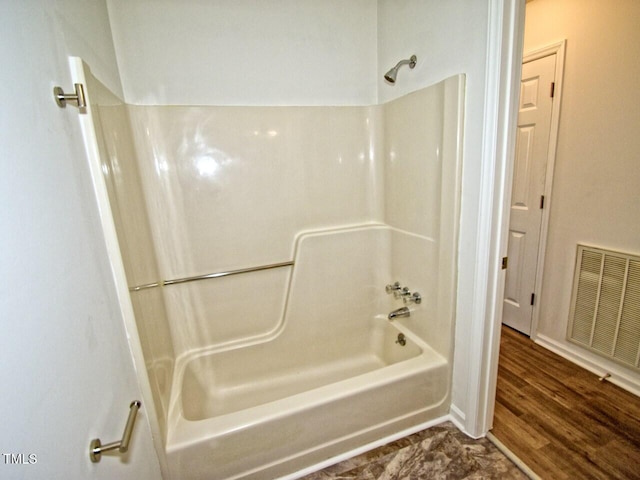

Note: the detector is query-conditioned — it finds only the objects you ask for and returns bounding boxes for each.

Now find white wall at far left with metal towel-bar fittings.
[0,0,160,479]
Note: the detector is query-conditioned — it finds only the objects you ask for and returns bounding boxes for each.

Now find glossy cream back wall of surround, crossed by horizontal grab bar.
[129,106,384,356]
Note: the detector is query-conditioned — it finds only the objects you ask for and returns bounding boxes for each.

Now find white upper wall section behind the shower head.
[376,0,488,105]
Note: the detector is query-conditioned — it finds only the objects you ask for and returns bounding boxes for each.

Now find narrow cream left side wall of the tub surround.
[83,65,175,438]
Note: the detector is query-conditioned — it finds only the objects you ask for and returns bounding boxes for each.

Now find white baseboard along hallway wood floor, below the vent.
[534,334,640,397]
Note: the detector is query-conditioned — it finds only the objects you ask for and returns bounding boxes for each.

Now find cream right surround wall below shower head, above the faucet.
[382,79,465,360]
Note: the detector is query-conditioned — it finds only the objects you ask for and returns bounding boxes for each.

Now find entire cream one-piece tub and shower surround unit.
[85,61,464,479]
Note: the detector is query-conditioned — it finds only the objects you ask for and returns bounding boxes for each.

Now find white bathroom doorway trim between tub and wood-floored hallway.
[462,0,565,438]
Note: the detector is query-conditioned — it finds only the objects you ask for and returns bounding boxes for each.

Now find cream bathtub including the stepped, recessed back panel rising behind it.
[167,225,450,480]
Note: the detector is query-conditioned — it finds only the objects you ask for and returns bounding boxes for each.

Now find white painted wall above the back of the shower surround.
[108,0,376,105]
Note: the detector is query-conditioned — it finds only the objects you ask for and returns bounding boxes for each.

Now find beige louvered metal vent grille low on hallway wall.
[567,245,640,369]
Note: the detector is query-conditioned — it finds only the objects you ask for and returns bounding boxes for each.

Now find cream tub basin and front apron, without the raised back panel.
[167,319,449,480]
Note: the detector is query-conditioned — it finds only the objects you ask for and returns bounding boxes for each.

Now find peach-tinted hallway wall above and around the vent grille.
[525,0,640,382]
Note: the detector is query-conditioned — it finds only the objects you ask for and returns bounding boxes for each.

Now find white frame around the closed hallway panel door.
[522,39,567,340]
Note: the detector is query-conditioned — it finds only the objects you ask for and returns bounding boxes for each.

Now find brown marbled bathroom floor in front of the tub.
[301,422,528,480]
